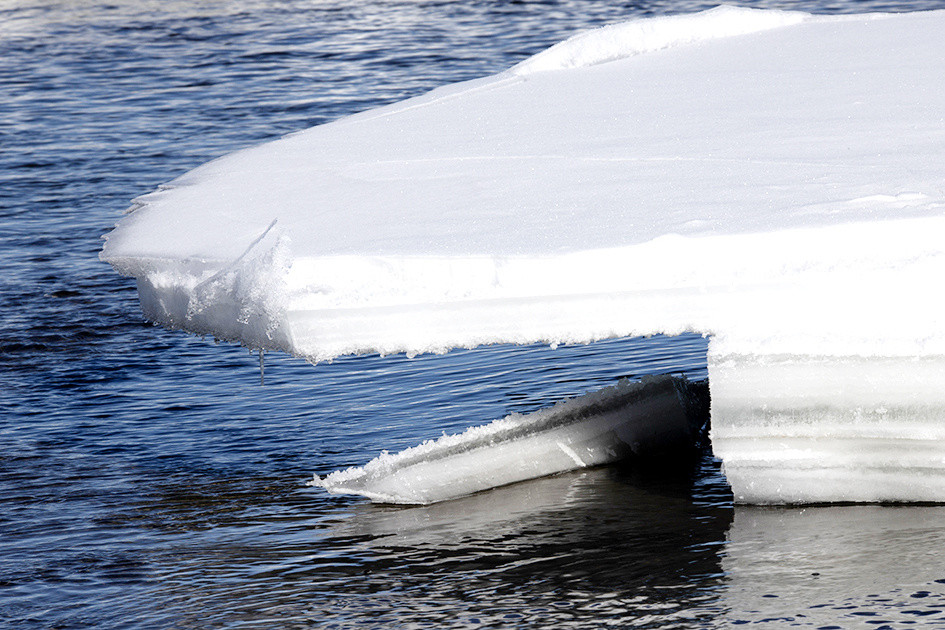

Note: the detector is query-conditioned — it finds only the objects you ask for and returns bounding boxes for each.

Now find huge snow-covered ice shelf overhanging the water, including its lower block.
[102,7,945,502]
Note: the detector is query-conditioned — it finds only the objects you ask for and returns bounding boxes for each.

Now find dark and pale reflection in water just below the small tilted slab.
[325,467,731,607]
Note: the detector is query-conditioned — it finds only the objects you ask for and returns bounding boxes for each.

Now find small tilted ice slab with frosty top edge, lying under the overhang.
[311,376,701,504]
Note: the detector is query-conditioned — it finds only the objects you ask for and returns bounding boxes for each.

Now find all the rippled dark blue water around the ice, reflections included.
[0,0,945,628]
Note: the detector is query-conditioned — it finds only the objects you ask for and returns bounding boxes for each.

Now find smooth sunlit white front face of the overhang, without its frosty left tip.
[288,218,945,357]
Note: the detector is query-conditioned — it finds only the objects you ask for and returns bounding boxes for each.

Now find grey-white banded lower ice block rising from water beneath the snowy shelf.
[709,356,945,504]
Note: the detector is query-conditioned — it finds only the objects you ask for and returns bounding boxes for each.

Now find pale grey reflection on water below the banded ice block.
[722,506,945,627]
